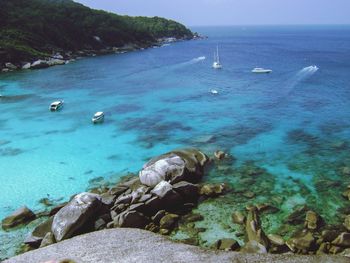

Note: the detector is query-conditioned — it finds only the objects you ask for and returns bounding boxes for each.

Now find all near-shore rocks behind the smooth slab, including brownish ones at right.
[2,149,350,262]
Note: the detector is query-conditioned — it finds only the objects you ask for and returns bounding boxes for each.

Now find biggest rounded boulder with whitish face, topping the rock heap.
[139,149,209,187]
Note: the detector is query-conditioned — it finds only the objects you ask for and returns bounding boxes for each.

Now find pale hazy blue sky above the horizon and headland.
[76,0,350,26]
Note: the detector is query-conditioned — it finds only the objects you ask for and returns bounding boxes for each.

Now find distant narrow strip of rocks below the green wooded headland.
[0,33,206,73]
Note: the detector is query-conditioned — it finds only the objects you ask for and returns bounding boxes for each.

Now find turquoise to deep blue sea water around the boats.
[0,26,350,258]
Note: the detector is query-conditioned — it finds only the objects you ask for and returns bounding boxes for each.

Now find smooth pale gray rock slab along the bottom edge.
[4,228,349,263]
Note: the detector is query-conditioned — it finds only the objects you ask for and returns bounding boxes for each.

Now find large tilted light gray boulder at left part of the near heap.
[51,193,102,242]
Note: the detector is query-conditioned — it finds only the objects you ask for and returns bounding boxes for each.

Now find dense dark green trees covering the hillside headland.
[0,0,192,63]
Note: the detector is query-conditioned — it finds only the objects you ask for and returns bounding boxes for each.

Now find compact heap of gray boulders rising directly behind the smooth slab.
[5,149,230,253]
